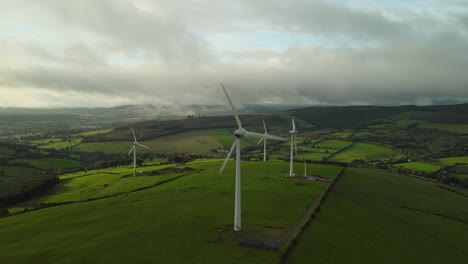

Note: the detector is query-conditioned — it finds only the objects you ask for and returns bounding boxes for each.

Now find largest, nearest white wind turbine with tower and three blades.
[219,84,287,231]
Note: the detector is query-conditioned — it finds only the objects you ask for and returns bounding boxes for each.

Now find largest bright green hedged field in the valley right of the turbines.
[331,143,404,162]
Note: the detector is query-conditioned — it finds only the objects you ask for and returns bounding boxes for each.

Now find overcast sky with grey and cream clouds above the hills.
[0,0,468,107]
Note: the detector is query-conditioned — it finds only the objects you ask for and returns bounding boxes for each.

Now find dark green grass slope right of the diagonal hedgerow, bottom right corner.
[287,168,468,264]
